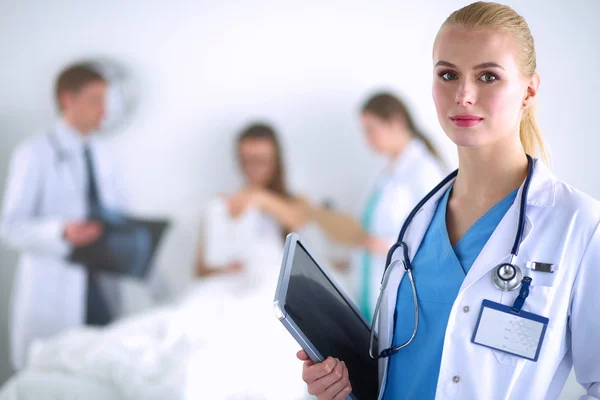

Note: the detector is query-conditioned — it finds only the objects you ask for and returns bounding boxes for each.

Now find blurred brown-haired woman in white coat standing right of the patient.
[313,92,443,319]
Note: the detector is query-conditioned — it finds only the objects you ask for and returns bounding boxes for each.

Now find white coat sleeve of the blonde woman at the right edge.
[569,220,600,400]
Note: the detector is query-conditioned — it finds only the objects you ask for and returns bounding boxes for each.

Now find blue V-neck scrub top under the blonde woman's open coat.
[383,187,518,400]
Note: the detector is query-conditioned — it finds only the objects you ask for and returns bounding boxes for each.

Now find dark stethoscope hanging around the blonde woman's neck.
[369,154,534,360]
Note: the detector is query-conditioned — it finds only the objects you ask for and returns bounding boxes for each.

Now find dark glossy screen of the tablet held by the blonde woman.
[284,243,378,400]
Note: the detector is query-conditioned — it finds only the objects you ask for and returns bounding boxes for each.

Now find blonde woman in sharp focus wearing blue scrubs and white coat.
[298,2,600,400]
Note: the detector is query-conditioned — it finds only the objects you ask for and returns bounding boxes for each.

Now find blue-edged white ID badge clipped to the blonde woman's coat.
[471,300,549,361]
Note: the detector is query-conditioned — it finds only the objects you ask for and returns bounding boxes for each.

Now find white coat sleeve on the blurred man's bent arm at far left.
[0,142,70,257]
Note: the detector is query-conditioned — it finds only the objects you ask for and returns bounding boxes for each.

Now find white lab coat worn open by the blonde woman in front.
[378,161,600,400]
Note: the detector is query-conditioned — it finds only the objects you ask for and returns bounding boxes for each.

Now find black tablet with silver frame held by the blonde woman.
[274,233,379,400]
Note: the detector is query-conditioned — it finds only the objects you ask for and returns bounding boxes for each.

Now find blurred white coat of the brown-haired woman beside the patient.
[353,138,444,310]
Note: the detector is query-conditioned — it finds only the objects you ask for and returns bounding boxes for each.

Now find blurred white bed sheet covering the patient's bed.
[0,234,306,400]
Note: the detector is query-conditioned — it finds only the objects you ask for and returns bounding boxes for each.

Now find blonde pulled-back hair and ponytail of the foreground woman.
[442,1,548,162]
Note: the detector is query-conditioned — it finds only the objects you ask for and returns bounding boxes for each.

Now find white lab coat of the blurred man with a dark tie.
[0,120,125,369]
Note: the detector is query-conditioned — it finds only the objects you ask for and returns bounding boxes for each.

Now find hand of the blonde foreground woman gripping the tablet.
[296,350,352,400]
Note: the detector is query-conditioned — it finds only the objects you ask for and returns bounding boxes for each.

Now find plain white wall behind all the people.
[0,0,600,398]
